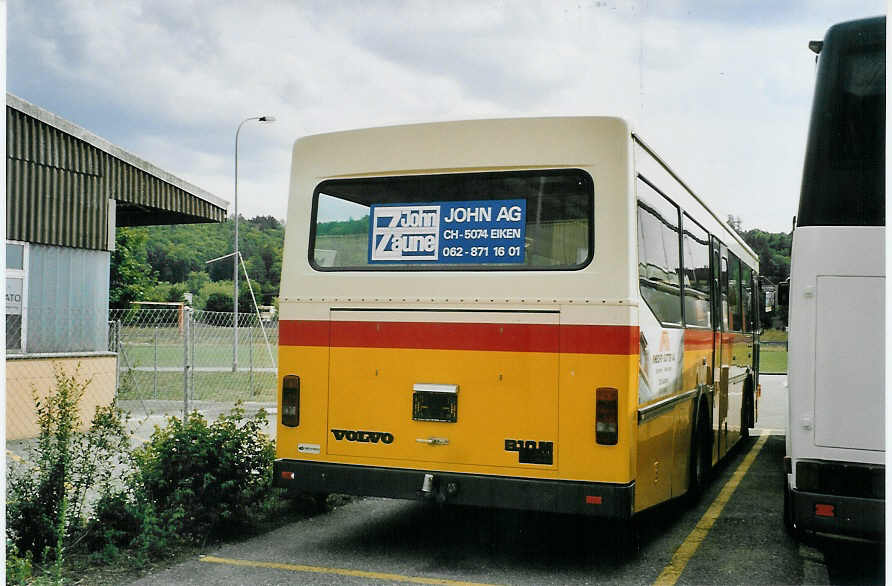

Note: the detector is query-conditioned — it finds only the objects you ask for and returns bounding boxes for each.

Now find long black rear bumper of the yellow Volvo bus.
[273,459,635,520]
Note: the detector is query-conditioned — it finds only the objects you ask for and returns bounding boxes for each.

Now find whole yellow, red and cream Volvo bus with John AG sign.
[274,117,759,526]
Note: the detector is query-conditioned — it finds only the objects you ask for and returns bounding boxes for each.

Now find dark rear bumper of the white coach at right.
[792,489,886,541]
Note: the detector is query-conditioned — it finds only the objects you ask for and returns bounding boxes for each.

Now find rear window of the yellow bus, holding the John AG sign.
[310,169,594,271]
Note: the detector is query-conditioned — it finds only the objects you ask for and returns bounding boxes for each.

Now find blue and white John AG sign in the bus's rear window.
[368,199,526,264]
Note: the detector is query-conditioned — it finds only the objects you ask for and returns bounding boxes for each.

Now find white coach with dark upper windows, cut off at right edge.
[784,17,886,539]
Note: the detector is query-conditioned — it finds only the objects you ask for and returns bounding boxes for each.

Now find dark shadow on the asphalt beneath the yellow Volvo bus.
[327,438,754,582]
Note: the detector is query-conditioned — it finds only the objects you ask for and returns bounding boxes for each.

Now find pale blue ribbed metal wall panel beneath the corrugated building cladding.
[25,244,110,354]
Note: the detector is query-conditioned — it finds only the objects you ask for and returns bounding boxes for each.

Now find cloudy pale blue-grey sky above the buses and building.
[6,0,886,232]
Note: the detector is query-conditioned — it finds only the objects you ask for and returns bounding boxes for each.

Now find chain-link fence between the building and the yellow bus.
[108,307,279,414]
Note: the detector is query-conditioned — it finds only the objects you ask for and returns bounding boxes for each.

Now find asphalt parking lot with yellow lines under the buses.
[127,376,885,585]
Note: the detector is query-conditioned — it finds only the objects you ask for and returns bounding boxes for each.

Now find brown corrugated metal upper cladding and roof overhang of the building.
[6,93,229,250]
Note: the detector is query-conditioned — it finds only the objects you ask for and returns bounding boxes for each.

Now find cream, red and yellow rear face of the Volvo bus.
[275,117,639,519]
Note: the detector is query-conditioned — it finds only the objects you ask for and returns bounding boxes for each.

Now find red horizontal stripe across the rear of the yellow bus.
[279,320,638,355]
